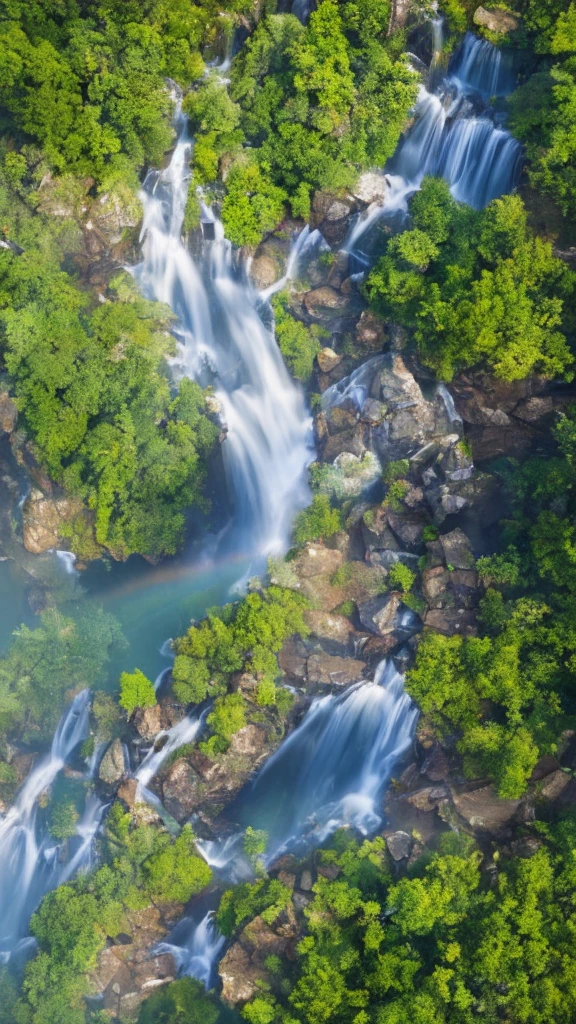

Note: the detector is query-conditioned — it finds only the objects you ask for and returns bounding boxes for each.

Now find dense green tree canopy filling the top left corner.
[0,0,249,188]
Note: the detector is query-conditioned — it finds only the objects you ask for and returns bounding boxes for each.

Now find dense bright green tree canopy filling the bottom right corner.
[231,820,576,1024]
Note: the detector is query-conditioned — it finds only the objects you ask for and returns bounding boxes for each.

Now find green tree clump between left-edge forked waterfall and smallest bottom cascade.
[12,804,211,1024]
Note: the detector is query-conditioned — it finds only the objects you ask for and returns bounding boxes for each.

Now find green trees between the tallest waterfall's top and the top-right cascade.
[186,0,417,245]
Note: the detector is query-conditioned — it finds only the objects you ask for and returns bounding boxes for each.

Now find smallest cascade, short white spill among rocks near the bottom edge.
[155,909,225,989]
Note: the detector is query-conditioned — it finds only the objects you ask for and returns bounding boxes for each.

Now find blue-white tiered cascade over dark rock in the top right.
[344,30,523,264]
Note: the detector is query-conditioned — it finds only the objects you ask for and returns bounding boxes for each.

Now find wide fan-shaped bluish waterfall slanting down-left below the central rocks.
[217,662,418,866]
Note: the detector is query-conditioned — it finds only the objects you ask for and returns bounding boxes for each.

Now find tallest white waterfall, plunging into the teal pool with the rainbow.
[134,116,314,557]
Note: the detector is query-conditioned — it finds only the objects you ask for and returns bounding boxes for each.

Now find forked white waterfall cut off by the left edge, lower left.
[0,690,104,962]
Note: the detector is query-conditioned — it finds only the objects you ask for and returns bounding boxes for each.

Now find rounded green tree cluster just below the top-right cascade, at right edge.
[366,178,576,380]
